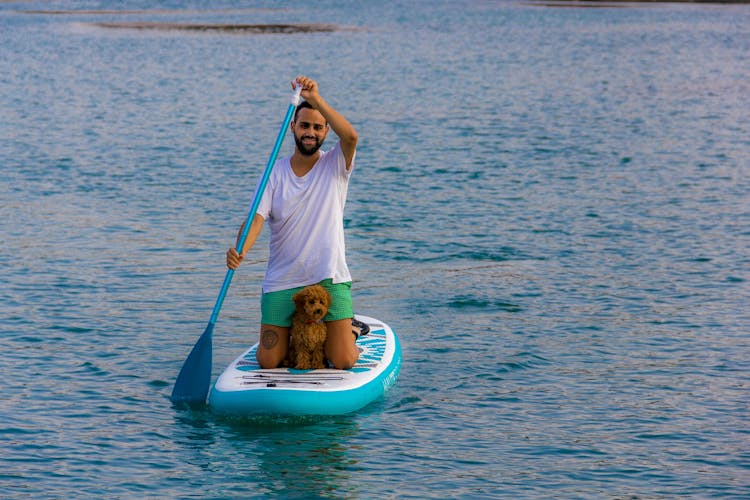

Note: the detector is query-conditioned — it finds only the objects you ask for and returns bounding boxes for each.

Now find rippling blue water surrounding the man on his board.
[0,0,750,498]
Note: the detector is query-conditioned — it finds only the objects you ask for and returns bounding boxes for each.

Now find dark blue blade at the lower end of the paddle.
[169,322,214,406]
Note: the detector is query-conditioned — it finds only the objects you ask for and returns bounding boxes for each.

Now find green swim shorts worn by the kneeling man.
[260,279,354,327]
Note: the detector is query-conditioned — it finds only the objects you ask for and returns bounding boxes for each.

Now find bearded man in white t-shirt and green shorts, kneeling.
[227,76,359,369]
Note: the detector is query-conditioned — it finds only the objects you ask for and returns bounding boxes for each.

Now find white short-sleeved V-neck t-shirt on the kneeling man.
[256,143,354,293]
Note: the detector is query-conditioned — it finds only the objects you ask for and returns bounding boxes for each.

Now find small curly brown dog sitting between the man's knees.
[284,285,331,370]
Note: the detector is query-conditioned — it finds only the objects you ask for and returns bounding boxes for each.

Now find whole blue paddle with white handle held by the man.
[170,80,302,406]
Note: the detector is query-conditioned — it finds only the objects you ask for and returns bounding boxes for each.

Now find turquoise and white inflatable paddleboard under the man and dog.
[208,315,401,416]
